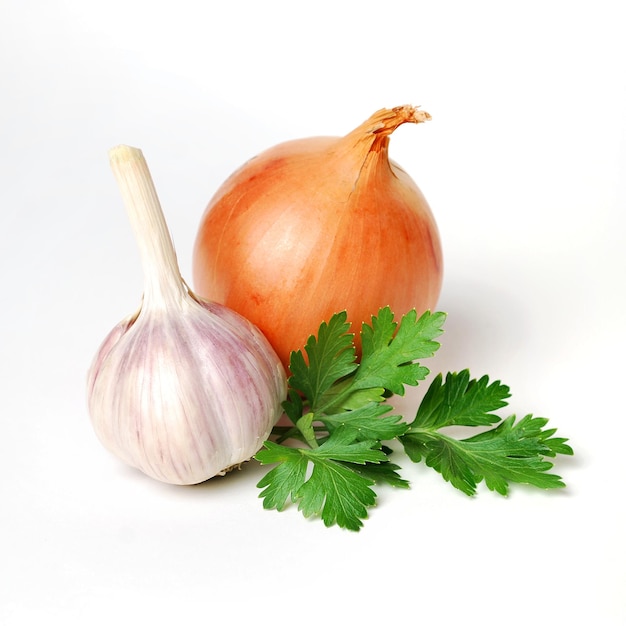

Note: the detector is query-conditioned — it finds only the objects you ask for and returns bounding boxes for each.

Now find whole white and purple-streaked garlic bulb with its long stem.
[87,146,287,484]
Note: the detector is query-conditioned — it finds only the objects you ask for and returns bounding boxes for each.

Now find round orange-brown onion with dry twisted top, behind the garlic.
[192,105,443,367]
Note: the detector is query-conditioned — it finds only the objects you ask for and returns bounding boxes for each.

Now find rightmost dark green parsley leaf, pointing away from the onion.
[400,370,573,495]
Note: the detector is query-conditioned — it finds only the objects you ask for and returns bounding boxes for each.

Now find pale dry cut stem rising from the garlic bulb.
[109,145,187,308]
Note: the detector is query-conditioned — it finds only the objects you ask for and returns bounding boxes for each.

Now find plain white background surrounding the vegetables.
[0,0,626,626]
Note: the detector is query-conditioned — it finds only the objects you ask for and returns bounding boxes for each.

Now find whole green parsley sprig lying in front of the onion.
[255,307,573,531]
